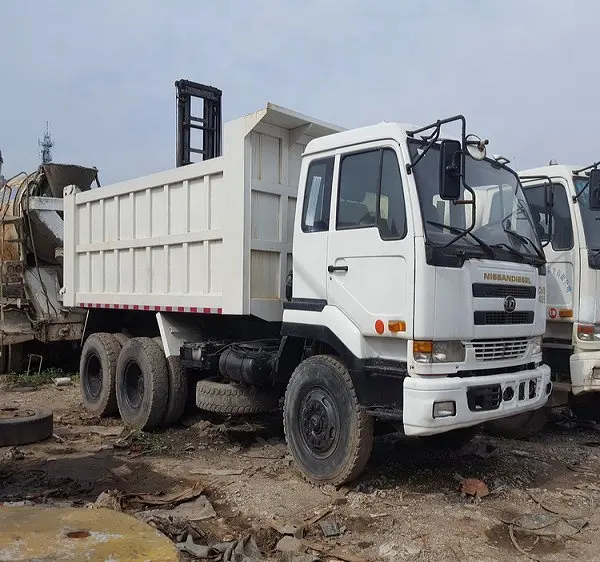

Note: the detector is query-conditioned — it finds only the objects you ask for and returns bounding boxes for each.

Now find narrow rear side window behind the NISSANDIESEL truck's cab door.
[302,157,333,232]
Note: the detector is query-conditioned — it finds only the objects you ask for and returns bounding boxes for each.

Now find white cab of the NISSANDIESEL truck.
[282,119,551,476]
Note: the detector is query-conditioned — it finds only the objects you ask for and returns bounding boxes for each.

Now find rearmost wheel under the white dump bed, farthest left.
[79,333,121,416]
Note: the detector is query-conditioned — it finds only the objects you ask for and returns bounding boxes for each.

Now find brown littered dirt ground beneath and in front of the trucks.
[0,386,600,562]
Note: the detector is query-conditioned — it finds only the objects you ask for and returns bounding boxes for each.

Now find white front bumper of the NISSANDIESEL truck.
[403,365,552,435]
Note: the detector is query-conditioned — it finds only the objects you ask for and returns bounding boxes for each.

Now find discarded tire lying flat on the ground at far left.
[0,407,53,447]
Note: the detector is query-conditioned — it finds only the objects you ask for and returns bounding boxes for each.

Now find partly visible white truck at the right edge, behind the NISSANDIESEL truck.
[504,162,600,421]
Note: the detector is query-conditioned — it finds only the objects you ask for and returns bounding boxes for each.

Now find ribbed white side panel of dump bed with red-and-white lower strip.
[64,157,242,314]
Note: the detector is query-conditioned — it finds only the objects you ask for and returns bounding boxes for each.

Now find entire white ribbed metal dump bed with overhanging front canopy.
[63,104,341,321]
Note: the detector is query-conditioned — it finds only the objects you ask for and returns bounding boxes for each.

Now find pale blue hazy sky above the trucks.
[0,0,600,184]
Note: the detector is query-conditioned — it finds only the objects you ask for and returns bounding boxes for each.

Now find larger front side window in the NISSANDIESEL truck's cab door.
[336,148,406,240]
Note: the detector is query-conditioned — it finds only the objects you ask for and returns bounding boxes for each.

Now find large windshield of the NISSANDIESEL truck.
[409,140,543,263]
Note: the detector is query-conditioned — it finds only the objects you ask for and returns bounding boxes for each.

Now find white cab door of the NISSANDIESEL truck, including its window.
[327,143,414,337]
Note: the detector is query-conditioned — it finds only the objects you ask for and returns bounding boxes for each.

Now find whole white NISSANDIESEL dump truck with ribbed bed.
[54,83,552,484]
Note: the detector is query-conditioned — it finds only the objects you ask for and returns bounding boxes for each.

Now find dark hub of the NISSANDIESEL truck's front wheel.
[300,388,340,458]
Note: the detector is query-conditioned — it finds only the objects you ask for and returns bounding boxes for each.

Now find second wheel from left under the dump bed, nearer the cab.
[116,338,169,429]
